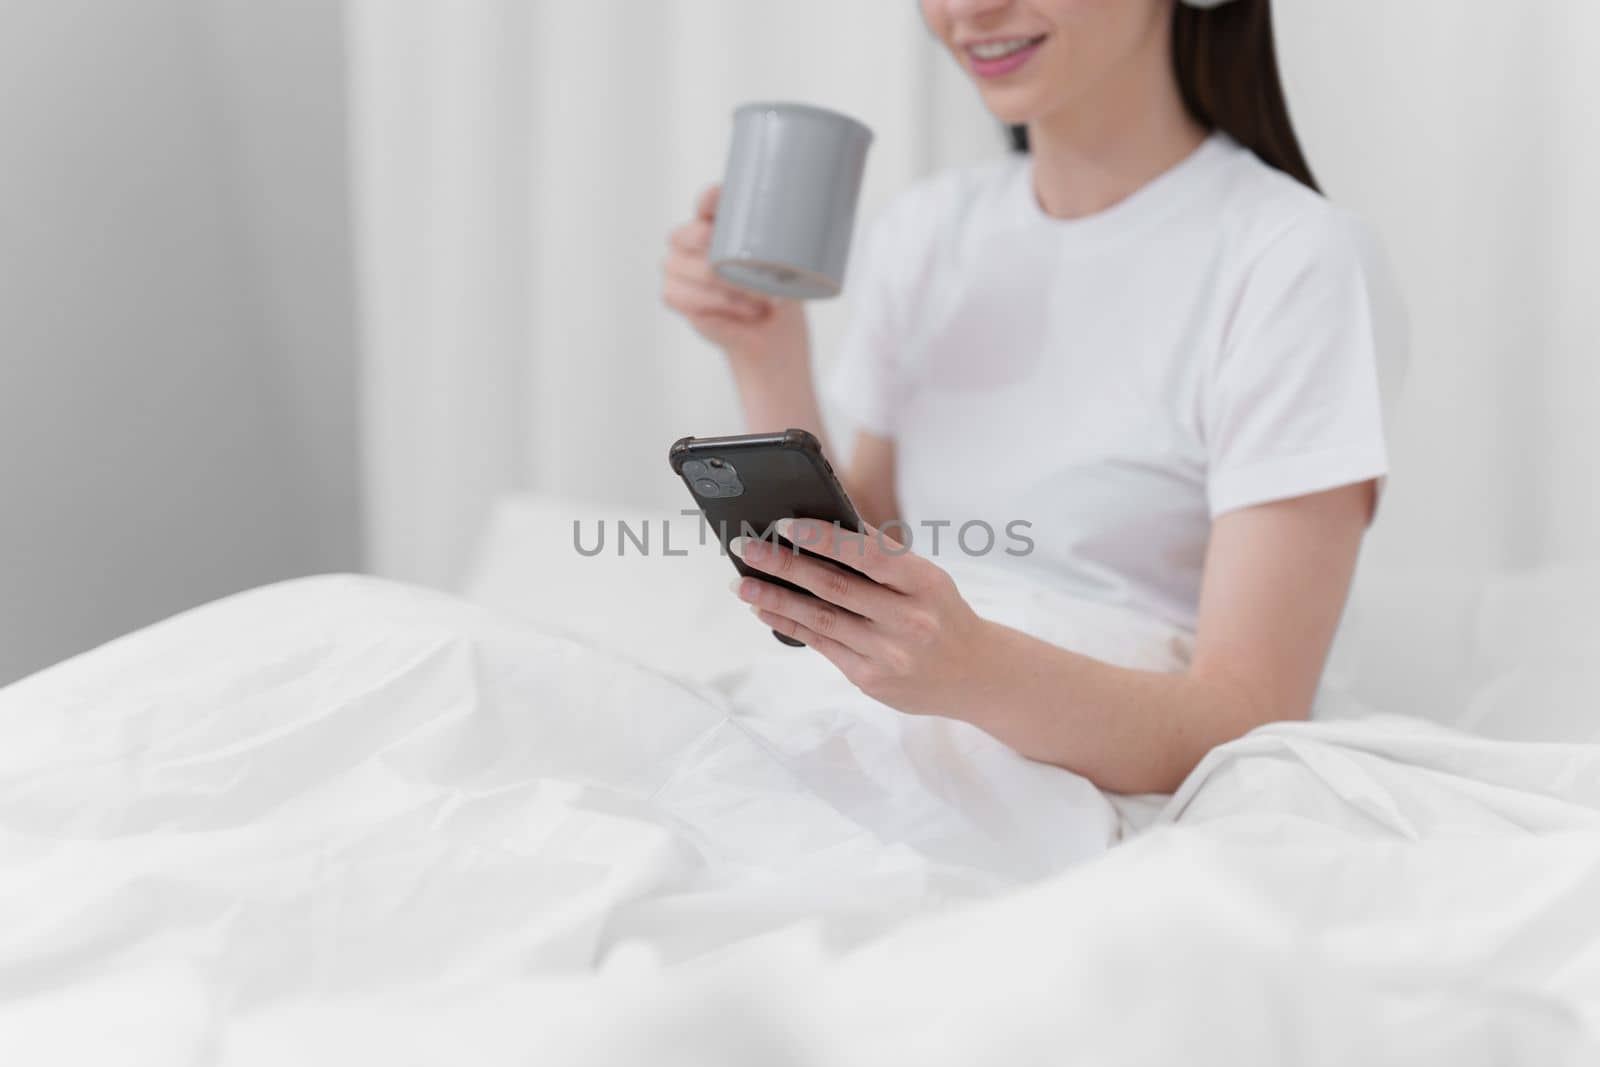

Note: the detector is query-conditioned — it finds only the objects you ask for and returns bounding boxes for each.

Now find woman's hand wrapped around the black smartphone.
[734,518,995,715]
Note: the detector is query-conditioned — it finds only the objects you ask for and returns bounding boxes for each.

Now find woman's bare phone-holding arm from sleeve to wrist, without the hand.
[947,483,1373,793]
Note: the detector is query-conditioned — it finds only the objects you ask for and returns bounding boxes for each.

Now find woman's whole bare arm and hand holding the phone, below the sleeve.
[739,482,1374,793]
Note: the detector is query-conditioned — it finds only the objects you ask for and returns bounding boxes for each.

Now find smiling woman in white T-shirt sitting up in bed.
[664,0,1386,792]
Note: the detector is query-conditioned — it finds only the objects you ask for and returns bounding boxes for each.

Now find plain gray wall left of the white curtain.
[0,0,360,683]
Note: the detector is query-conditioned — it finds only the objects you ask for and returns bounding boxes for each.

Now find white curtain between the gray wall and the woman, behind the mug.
[349,0,1002,584]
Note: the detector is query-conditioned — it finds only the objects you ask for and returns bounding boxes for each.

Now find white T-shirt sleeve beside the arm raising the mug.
[822,204,906,437]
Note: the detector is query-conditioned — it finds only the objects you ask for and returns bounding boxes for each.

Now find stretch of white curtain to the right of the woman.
[1277,0,1600,568]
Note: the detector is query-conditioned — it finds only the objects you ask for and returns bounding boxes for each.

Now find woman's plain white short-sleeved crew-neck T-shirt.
[826,134,1387,630]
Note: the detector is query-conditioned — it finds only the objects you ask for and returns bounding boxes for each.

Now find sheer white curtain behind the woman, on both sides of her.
[347,0,1600,584]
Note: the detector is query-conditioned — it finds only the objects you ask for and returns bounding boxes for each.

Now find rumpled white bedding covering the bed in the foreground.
[0,579,1600,1064]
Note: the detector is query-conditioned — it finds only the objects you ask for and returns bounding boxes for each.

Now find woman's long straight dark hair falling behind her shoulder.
[1010,0,1320,192]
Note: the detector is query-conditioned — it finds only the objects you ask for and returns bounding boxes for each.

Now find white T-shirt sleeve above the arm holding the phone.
[1203,210,1389,518]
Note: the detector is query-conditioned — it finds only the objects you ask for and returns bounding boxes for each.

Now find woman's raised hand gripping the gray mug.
[661,186,810,370]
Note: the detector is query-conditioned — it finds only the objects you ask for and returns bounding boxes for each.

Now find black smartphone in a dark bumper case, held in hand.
[667,429,861,646]
